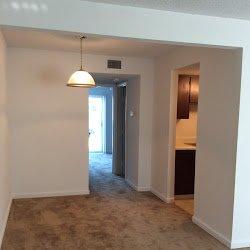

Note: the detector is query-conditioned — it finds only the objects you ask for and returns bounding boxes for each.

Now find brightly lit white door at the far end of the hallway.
[89,96,105,153]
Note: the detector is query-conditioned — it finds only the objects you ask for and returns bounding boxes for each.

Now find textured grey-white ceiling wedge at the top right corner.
[85,0,250,20]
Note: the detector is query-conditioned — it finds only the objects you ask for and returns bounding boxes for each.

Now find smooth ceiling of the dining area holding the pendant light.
[2,28,176,57]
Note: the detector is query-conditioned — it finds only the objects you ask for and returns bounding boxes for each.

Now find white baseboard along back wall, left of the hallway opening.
[13,189,90,199]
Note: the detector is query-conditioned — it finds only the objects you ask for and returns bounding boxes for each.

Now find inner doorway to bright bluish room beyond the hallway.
[89,86,113,174]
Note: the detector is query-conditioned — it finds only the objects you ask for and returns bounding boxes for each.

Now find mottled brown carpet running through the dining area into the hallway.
[1,154,231,250]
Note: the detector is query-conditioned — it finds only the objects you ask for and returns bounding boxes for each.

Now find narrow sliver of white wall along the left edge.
[0,30,11,248]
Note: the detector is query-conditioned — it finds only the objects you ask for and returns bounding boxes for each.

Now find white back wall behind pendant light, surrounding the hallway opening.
[8,48,153,197]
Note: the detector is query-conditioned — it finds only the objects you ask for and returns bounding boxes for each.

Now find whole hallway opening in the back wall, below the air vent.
[89,73,140,190]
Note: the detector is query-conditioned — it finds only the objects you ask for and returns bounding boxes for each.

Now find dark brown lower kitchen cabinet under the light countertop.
[175,150,195,195]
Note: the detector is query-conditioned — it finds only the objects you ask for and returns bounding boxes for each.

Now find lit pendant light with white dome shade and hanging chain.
[67,36,95,88]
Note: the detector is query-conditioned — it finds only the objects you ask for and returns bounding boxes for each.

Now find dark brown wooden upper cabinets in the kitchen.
[177,75,199,119]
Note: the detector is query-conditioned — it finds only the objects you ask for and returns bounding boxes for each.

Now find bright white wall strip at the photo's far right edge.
[232,46,250,248]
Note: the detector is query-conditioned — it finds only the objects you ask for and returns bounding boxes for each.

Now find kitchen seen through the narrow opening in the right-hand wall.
[174,65,199,215]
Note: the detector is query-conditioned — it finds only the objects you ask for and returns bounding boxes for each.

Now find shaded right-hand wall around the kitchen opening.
[152,48,241,245]
